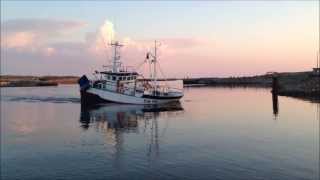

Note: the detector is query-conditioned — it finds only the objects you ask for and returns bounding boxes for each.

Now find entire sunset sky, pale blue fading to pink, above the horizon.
[1,1,319,77]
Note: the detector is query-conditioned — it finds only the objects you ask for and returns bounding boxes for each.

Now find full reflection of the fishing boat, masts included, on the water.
[80,102,183,160]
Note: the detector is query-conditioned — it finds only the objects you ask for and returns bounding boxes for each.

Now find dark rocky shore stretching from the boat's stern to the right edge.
[183,72,320,99]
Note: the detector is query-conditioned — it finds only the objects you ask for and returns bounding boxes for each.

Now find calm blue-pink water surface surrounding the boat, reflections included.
[1,86,320,180]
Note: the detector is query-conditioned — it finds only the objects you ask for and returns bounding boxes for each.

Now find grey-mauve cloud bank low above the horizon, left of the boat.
[1,46,97,75]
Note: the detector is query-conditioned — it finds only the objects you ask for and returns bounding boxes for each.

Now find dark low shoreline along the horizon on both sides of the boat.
[0,71,320,99]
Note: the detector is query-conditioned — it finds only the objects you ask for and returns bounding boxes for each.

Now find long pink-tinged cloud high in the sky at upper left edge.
[1,19,86,52]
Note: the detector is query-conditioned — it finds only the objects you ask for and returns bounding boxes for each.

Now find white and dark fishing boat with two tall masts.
[78,41,183,104]
